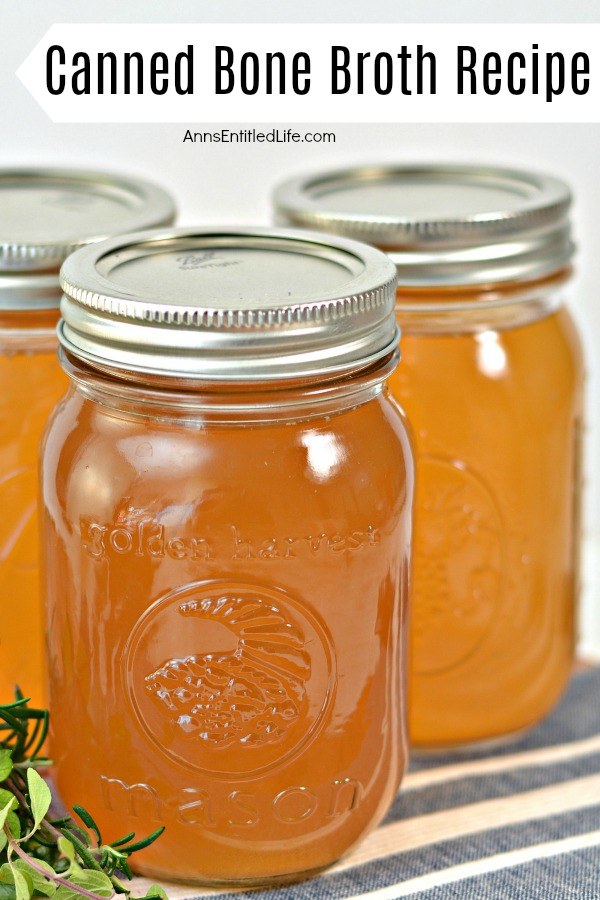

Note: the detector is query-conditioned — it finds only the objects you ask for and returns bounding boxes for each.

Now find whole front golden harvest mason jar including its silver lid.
[42,229,413,883]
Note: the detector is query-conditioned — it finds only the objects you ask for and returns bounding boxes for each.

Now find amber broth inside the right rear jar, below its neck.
[390,298,583,747]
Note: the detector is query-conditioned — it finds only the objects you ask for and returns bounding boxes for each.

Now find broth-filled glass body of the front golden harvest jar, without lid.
[42,372,413,883]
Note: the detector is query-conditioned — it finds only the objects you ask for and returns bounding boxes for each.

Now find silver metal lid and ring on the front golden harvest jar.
[59,228,398,382]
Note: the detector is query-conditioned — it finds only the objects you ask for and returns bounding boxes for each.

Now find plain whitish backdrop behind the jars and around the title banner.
[0,0,600,655]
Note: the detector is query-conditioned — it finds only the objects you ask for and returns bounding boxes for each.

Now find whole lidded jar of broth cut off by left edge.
[0,169,174,705]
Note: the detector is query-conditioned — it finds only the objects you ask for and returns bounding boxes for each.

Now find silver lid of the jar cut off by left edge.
[0,169,175,310]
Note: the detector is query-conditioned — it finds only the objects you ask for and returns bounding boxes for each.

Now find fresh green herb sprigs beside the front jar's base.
[0,690,168,900]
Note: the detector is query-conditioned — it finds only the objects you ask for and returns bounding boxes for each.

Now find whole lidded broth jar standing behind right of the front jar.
[276,165,583,748]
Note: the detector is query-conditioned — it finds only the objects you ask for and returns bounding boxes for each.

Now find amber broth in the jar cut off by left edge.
[0,312,67,705]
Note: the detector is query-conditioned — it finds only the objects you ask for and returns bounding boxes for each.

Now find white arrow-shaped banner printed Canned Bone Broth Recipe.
[17,24,600,124]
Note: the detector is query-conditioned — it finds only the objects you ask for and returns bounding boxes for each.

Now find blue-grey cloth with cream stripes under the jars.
[130,669,600,900]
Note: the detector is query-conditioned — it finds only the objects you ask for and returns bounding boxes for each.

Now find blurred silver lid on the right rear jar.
[275,164,573,287]
